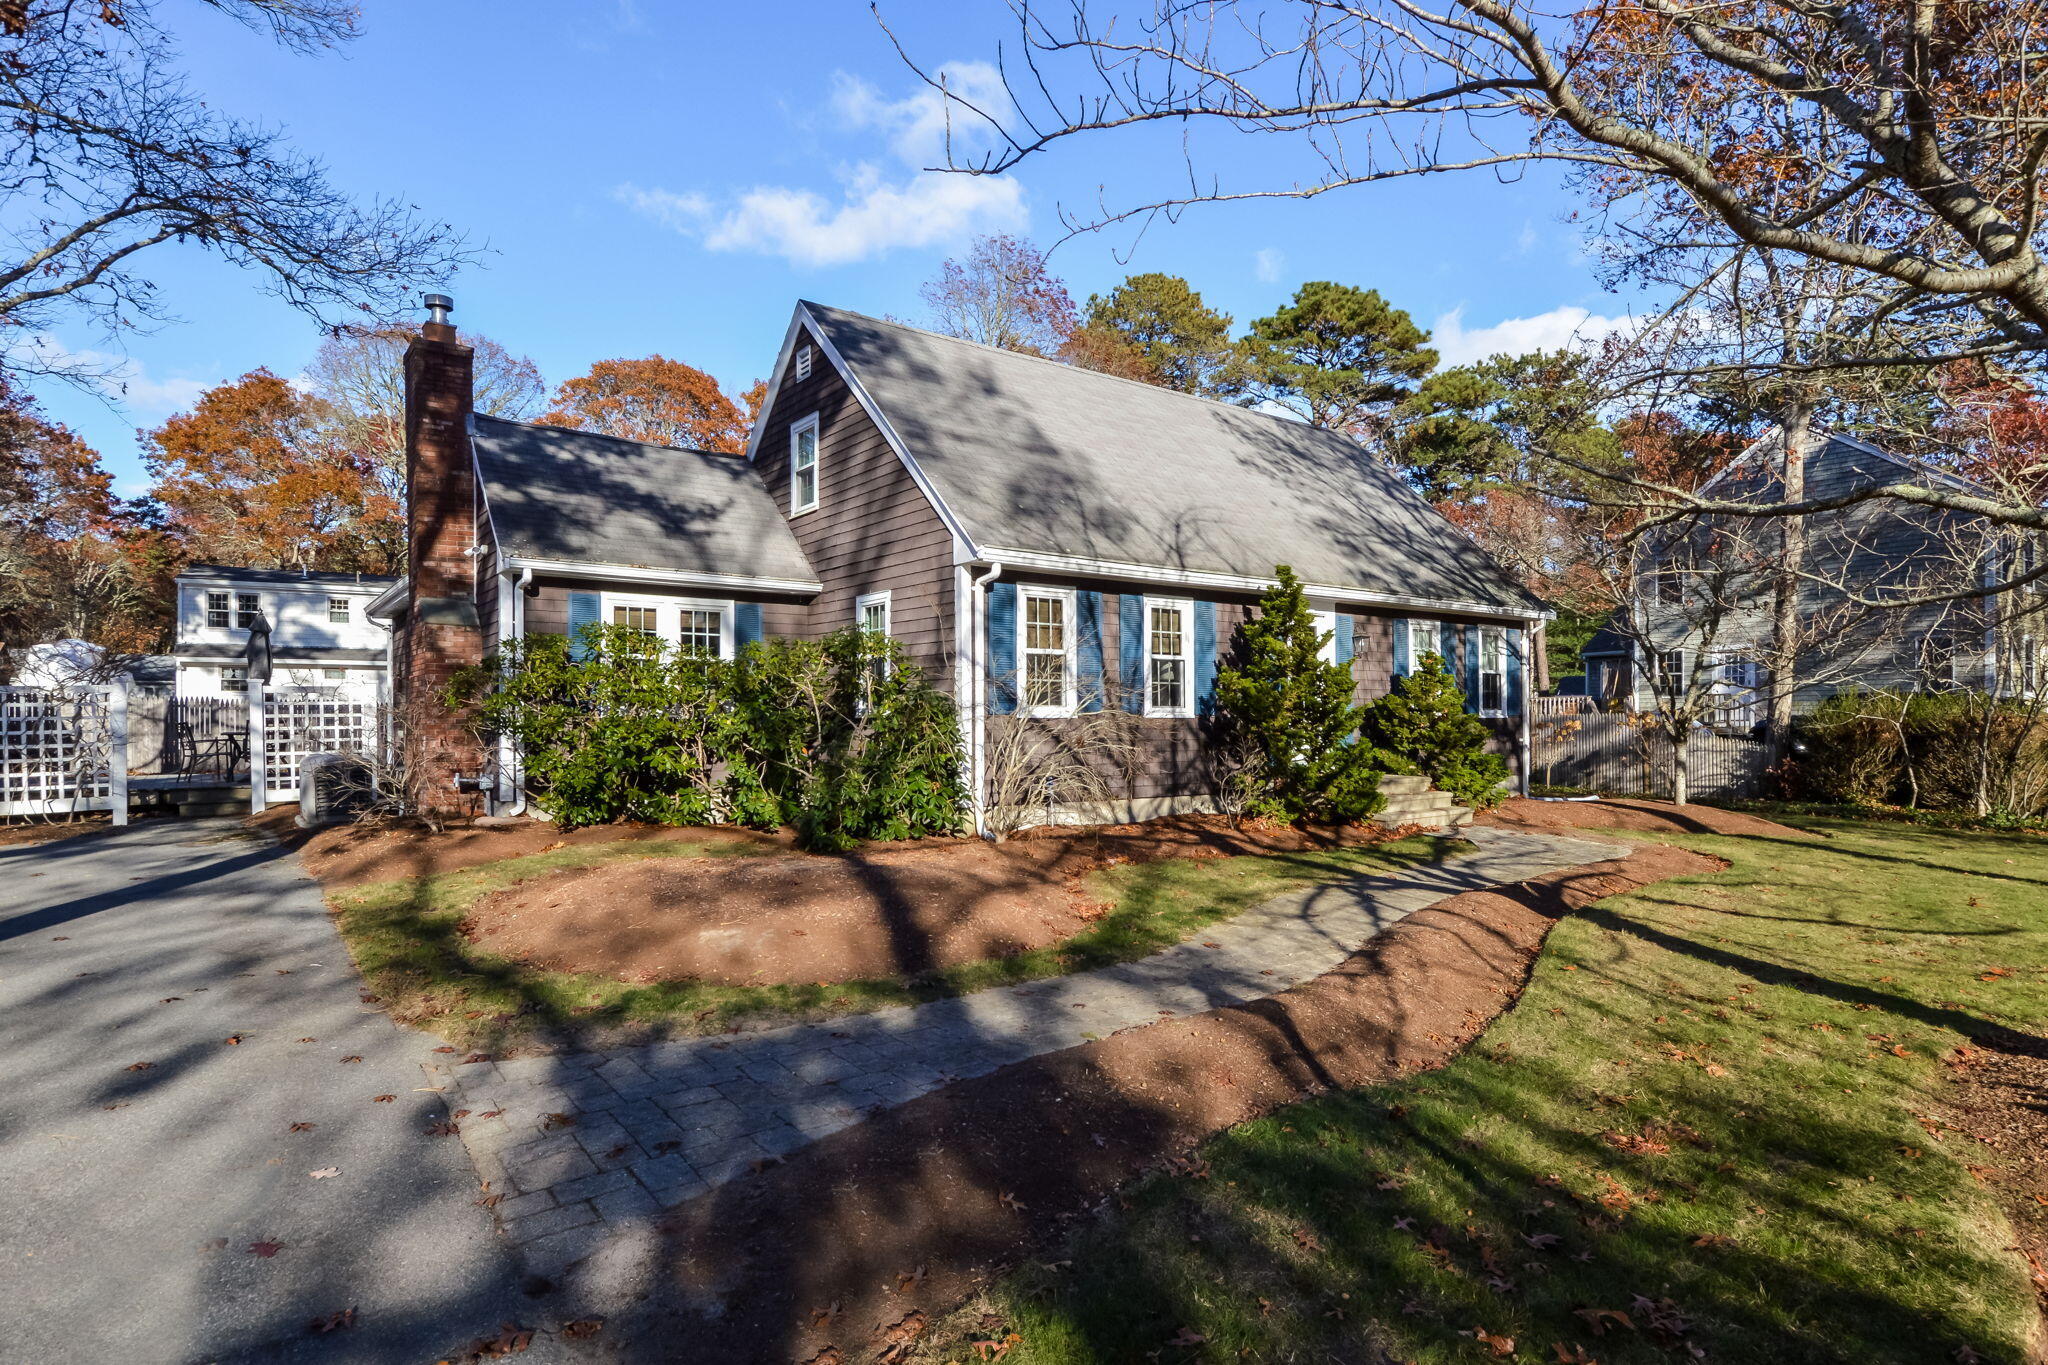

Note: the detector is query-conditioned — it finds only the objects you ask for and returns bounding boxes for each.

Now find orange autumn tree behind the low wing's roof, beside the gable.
[541,356,766,454]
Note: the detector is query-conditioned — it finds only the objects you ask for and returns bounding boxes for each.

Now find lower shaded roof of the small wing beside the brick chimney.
[473,415,817,589]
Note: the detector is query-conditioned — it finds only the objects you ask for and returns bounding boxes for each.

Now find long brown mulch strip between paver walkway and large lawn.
[608,847,1718,1365]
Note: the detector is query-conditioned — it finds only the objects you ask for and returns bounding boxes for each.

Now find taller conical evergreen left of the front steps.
[1217,565,1384,823]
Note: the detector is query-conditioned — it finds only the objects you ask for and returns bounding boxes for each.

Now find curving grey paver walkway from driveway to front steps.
[444,827,1616,1273]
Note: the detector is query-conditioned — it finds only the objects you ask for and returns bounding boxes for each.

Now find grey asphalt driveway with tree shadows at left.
[0,821,551,1363]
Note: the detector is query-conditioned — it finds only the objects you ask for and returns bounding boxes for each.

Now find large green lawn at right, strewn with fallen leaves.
[926,819,2048,1365]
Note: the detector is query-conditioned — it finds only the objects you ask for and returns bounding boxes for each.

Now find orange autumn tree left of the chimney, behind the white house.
[141,370,406,573]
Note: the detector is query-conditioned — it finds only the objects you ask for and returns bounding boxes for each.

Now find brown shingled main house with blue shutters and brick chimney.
[383,303,1548,834]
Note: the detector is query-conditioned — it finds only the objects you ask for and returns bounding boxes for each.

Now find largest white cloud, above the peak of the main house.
[612,61,1028,266]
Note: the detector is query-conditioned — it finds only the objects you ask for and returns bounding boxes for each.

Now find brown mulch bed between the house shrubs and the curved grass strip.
[463,817,1425,986]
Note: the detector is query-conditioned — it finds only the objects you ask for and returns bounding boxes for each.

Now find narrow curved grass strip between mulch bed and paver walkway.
[328,837,1464,1050]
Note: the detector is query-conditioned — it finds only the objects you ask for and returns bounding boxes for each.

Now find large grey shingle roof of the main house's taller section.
[784,303,1544,614]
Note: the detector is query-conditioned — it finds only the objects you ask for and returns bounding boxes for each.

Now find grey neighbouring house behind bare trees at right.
[1579,432,2048,731]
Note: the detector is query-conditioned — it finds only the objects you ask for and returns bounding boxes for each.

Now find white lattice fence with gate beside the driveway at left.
[0,684,381,825]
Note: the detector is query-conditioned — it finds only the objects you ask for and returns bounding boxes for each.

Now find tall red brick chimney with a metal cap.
[397,295,483,812]
